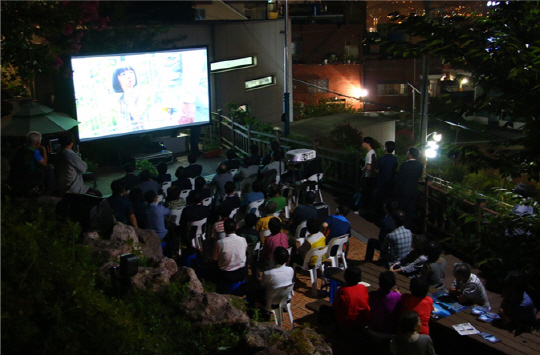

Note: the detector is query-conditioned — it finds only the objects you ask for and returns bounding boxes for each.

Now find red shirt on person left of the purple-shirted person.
[332,284,370,330]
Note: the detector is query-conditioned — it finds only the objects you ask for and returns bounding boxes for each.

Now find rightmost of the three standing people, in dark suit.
[395,147,424,229]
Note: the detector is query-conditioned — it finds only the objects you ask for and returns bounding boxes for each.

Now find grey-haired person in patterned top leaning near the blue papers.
[450,263,491,310]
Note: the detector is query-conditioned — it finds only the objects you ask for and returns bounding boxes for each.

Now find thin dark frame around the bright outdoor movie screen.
[70,44,212,142]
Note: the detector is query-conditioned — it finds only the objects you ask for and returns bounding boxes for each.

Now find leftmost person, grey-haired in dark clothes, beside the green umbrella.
[9,131,47,195]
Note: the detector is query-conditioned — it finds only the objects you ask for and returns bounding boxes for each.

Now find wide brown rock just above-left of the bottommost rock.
[180,293,249,327]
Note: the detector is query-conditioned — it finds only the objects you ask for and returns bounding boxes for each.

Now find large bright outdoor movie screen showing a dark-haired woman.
[71,47,210,141]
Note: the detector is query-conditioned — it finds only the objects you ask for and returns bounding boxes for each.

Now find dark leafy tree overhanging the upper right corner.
[390,1,540,180]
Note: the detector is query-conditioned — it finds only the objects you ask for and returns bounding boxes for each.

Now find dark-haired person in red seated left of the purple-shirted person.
[332,266,371,331]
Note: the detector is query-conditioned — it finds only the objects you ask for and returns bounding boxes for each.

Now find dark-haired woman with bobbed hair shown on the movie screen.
[112,64,147,131]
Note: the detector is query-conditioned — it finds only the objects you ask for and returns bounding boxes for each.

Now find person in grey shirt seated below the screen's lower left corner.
[55,131,103,197]
